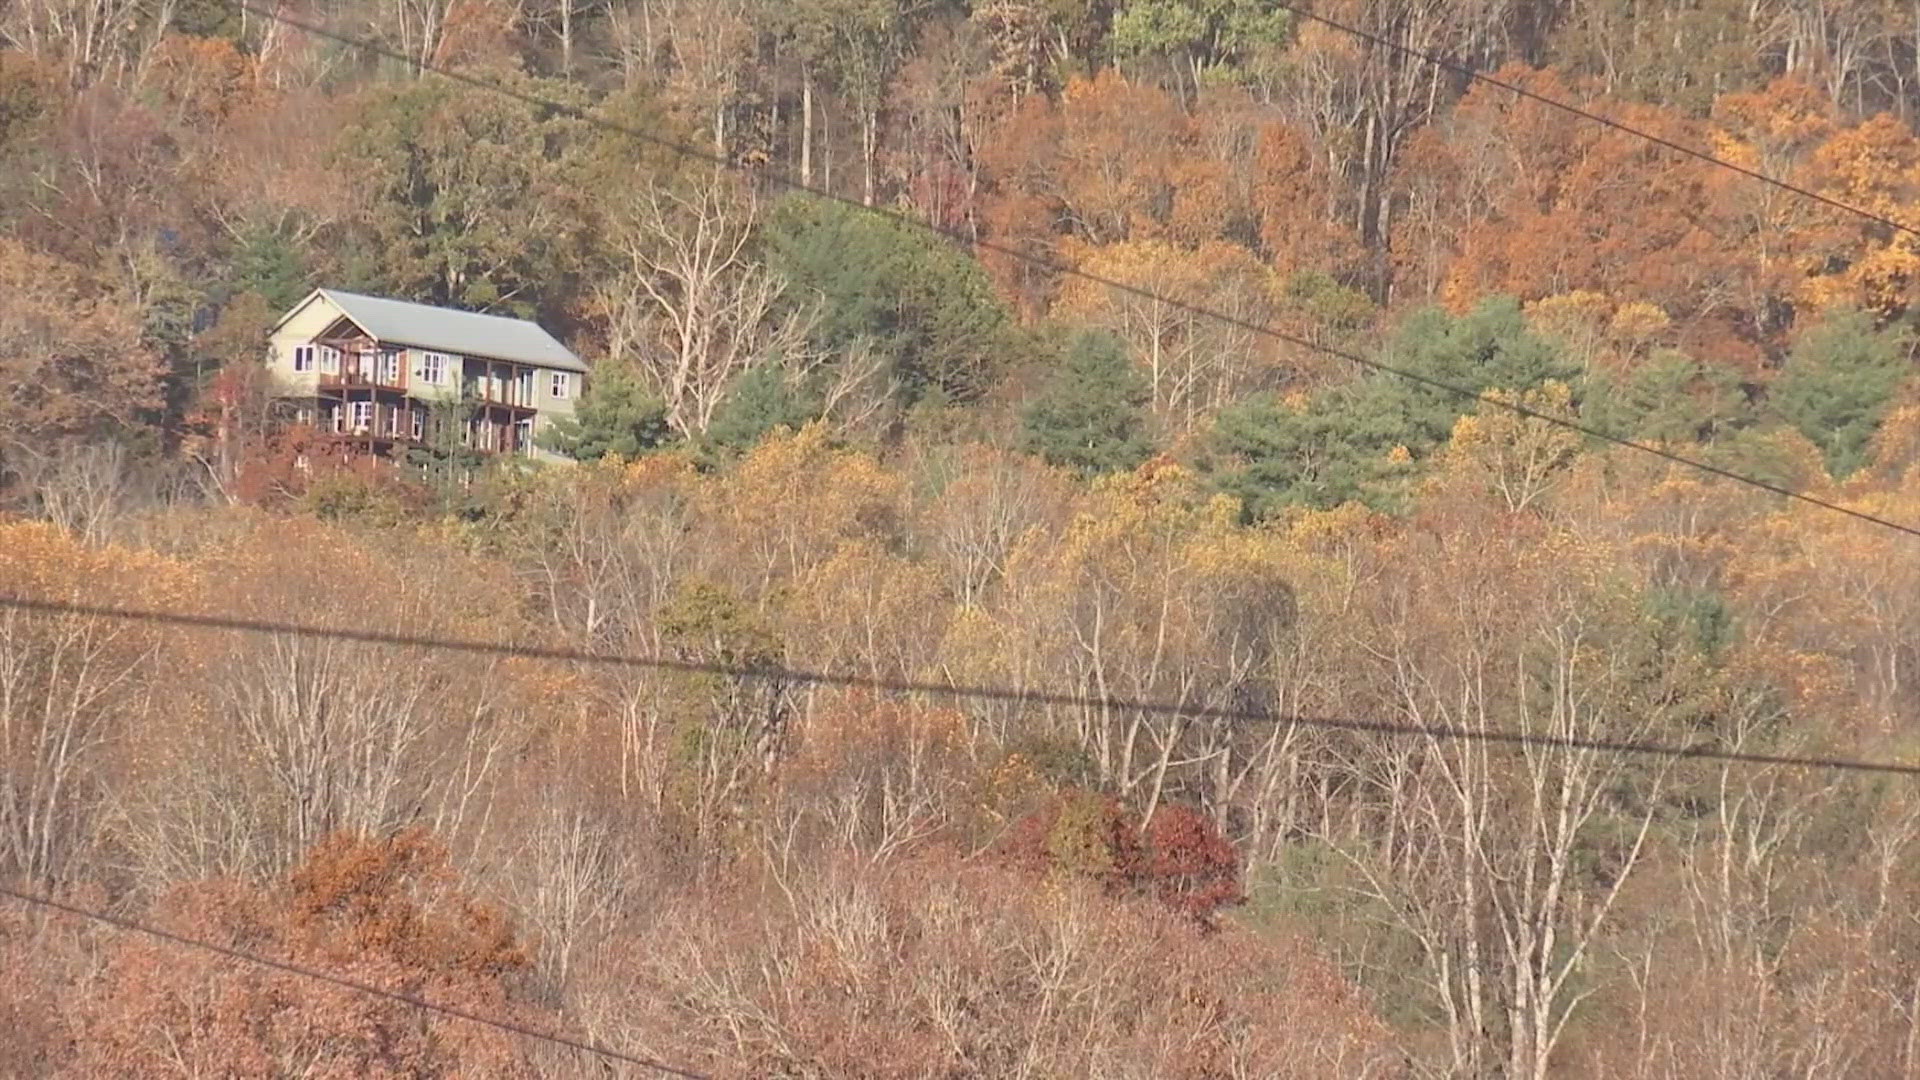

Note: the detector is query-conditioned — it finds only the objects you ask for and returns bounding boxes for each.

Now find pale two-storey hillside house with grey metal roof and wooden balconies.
[267,288,588,457]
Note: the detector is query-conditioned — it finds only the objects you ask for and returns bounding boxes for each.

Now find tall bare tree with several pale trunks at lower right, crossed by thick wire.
[1323,534,1672,1078]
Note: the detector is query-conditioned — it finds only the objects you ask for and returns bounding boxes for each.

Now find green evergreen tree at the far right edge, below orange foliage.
[1770,311,1912,479]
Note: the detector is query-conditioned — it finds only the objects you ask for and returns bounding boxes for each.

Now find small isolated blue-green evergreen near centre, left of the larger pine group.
[1025,331,1154,477]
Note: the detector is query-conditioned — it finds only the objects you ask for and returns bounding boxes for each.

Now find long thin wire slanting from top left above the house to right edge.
[234,2,1920,538]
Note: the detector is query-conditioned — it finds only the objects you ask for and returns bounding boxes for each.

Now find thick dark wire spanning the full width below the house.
[0,596,1920,776]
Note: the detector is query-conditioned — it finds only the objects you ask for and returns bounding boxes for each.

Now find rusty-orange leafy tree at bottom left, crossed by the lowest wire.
[63,830,543,1076]
